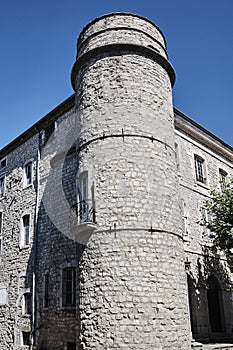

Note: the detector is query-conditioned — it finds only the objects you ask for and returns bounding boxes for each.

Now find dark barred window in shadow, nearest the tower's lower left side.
[62,267,76,306]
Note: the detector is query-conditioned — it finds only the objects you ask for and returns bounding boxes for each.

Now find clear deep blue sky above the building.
[0,0,233,148]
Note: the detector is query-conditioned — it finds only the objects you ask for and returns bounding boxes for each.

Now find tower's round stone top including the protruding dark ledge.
[71,13,175,90]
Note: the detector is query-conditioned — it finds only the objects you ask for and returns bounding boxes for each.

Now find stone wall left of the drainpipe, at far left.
[0,136,38,349]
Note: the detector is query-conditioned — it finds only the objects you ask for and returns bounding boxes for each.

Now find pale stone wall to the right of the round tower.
[176,121,233,341]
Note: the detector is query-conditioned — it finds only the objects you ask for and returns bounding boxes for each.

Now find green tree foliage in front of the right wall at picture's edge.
[202,179,233,256]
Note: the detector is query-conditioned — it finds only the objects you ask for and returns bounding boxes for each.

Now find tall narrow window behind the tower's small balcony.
[78,171,88,222]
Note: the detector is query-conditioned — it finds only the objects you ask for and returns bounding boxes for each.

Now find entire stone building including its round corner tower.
[0,13,233,350]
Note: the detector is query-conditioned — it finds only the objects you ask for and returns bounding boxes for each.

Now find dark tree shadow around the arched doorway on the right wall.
[187,247,233,343]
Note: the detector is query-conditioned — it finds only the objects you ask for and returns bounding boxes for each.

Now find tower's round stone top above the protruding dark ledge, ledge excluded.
[77,13,167,59]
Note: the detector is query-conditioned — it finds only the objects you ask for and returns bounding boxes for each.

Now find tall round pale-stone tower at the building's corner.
[72,13,190,350]
